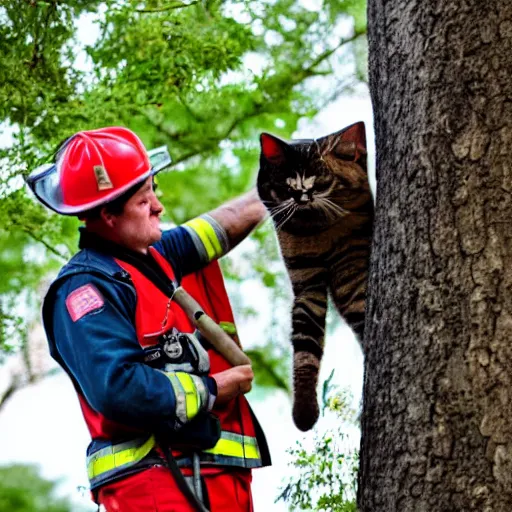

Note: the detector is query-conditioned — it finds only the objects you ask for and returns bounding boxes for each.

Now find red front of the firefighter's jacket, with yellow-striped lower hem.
[112,248,270,474]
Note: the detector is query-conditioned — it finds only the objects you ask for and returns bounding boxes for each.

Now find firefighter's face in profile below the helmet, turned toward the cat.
[113,177,164,252]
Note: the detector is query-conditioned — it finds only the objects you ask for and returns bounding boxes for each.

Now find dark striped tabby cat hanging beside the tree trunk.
[257,122,373,431]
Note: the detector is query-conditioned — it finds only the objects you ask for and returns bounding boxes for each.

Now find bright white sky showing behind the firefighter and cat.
[0,5,375,512]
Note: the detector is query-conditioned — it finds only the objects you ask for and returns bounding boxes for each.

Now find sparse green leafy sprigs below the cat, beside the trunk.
[276,371,359,512]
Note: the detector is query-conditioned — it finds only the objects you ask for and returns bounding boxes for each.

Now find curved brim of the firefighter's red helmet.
[26,146,172,215]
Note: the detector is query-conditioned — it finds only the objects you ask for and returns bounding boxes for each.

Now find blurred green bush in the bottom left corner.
[0,464,77,512]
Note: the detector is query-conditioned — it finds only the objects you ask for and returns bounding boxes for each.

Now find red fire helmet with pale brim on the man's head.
[27,126,171,215]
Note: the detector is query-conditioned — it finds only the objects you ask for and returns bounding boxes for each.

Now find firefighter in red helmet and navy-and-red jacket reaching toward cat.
[28,127,270,512]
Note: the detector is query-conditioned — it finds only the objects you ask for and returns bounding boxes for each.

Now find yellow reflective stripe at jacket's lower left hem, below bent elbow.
[87,436,155,480]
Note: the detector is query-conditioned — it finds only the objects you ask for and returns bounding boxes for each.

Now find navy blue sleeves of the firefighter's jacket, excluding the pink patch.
[43,227,216,432]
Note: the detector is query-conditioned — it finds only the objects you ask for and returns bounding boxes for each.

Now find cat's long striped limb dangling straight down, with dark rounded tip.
[292,280,327,432]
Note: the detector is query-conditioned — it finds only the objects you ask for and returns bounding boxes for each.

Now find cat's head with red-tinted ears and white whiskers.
[258,122,372,227]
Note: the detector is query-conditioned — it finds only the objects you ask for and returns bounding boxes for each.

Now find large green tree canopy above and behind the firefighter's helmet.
[0,0,365,362]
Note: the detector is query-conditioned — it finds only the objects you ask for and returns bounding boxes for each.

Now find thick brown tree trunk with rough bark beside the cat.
[359,0,512,512]
